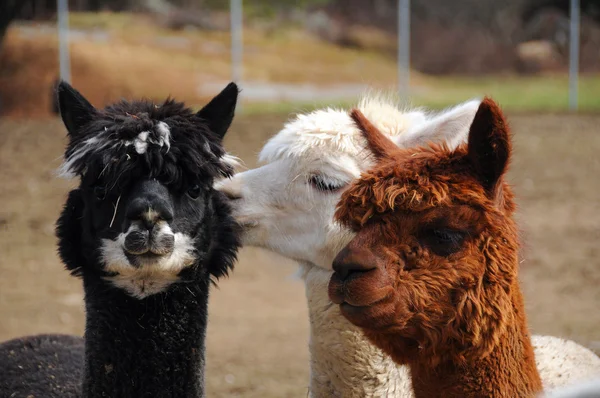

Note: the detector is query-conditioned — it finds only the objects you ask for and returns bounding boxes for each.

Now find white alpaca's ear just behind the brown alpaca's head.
[393,99,481,149]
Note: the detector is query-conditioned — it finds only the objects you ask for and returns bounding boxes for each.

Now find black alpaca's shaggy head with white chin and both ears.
[57,82,239,299]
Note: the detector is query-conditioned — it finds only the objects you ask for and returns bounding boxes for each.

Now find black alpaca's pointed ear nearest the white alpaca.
[196,82,239,139]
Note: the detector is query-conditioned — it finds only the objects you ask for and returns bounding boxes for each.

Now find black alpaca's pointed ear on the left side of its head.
[56,81,96,137]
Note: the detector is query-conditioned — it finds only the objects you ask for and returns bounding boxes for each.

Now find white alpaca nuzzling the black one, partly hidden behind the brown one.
[217,98,600,397]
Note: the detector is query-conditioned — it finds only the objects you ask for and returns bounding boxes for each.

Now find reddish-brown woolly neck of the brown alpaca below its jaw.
[410,289,542,398]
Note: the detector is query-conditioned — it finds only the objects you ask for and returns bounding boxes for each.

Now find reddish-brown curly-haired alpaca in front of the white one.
[329,98,542,398]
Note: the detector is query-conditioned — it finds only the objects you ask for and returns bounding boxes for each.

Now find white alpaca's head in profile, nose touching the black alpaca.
[217,97,480,269]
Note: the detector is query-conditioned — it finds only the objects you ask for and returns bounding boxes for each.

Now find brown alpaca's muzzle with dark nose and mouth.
[329,242,394,326]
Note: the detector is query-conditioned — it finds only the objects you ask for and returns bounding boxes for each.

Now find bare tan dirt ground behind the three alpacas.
[0,115,600,397]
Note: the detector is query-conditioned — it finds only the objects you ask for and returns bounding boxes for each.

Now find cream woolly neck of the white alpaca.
[302,265,412,398]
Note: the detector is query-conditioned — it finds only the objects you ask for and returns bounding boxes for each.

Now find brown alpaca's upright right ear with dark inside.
[468,97,511,199]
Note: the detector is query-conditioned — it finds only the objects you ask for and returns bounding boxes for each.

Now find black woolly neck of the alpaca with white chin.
[83,274,209,398]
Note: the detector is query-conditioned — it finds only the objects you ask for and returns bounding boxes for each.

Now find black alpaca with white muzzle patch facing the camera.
[0,79,239,397]
